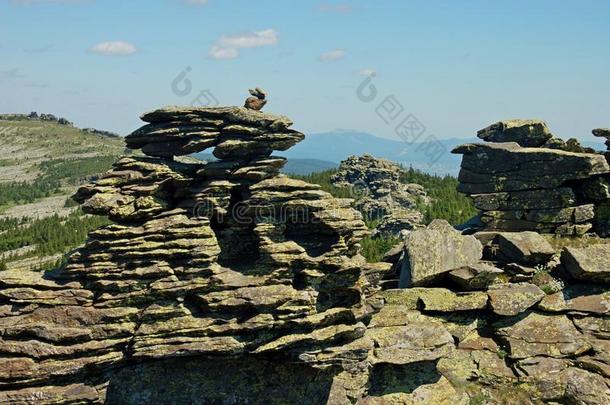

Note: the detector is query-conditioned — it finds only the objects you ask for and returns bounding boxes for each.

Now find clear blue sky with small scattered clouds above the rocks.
[0,0,610,140]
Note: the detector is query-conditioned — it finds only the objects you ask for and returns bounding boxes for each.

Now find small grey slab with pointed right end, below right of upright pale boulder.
[487,283,546,316]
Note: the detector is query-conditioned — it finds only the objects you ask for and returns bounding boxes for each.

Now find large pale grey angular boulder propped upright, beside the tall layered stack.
[400,220,483,287]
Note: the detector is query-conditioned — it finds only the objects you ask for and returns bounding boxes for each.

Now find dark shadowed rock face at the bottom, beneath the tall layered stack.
[106,357,340,405]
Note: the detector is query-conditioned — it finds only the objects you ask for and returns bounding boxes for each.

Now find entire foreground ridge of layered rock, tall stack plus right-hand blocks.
[0,107,610,405]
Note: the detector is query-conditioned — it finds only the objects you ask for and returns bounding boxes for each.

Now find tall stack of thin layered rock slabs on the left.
[0,107,374,404]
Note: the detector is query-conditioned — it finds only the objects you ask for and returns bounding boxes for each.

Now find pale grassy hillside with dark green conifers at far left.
[0,121,124,269]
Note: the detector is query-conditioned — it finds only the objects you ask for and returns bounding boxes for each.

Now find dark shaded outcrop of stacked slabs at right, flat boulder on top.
[453,120,610,234]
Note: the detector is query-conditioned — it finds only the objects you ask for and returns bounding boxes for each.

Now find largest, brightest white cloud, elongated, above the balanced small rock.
[208,29,279,59]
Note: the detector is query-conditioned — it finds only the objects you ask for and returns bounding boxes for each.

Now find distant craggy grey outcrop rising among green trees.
[331,154,430,236]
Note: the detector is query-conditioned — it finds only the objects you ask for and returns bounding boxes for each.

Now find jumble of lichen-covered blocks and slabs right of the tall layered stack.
[380,221,610,404]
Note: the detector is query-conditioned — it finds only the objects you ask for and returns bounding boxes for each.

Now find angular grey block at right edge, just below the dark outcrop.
[561,244,610,282]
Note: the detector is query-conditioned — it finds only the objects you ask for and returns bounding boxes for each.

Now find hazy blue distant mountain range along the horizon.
[277,130,606,175]
